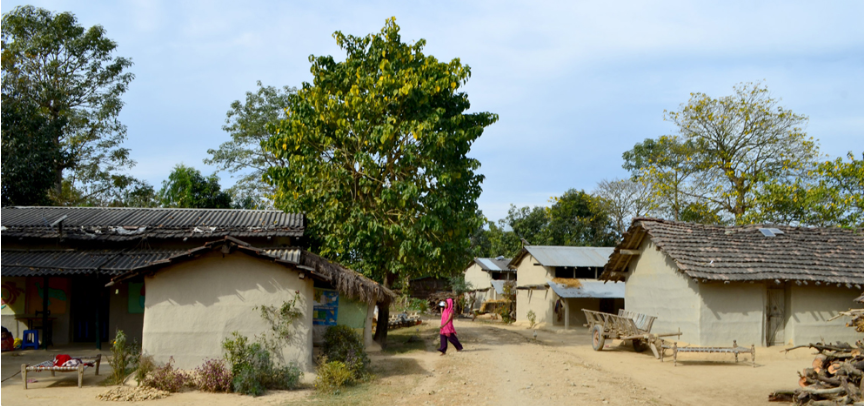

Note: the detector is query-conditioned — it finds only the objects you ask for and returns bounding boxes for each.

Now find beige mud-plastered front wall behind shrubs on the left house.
[143,252,313,371]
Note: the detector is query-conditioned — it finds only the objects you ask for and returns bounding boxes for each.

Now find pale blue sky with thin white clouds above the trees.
[0,0,864,220]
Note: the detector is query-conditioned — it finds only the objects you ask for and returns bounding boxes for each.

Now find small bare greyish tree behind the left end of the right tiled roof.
[593,179,654,235]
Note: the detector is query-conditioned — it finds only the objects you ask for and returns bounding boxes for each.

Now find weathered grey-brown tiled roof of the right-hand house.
[601,218,864,286]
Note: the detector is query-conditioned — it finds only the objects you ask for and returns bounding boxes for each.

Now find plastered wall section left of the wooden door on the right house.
[700,282,767,347]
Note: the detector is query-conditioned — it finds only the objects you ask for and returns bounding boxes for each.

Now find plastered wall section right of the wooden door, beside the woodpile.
[785,284,862,345]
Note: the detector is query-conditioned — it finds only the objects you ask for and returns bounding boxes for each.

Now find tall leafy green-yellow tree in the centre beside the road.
[265,18,498,342]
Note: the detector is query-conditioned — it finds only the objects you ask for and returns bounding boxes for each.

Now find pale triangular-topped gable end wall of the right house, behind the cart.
[624,238,702,344]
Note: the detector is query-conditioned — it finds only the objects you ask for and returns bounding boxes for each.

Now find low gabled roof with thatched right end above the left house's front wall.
[102,237,396,304]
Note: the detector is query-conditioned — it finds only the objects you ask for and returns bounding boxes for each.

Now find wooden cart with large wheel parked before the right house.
[582,309,681,358]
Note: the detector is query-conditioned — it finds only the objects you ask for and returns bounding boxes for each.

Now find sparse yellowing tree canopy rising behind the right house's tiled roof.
[624,83,818,223]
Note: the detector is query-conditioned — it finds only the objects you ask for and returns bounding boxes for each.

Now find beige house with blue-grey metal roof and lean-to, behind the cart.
[508,245,624,329]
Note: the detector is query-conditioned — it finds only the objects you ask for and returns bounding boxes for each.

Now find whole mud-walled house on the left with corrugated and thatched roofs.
[0,207,394,369]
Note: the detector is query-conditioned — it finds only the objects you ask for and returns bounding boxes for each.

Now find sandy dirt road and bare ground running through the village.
[0,320,812,406]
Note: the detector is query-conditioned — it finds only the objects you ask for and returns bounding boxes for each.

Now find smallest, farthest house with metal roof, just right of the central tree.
[463,256,516,310]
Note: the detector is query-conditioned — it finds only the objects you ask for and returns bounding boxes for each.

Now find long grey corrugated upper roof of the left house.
[0,207,305,241]
